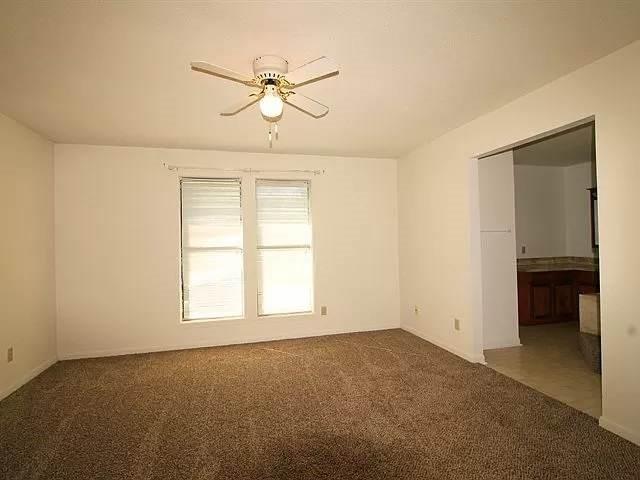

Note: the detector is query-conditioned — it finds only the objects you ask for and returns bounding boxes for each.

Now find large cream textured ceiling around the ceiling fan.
[0,0,640,157]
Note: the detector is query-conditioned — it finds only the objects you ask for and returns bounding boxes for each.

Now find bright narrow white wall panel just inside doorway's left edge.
[478,150,520,349]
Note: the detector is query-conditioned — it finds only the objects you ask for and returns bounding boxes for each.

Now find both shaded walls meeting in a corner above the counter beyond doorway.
[514,161,596,258]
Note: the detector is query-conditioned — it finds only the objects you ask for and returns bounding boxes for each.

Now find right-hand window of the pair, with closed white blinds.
[256,180,313,315]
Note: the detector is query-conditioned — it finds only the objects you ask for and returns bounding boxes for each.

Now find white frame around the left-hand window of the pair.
[178,175,247,325]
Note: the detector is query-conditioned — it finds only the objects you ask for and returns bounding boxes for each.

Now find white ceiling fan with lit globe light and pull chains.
[191,55,339,148]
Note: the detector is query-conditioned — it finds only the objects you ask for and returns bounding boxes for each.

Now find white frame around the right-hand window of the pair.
[252,177,316,319]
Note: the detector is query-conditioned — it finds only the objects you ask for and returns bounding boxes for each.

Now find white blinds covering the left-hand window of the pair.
[181,178,244,320]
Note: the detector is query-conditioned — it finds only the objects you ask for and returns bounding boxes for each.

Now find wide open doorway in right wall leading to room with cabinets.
[478,120,602,417]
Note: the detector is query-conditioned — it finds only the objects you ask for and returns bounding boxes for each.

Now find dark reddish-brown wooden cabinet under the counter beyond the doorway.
[518,270,598,325]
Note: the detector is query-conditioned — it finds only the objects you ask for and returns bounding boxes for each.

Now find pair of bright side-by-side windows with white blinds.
[180,178,313,321]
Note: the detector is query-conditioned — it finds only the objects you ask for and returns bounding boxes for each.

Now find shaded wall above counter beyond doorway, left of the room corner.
[514,164,566,258]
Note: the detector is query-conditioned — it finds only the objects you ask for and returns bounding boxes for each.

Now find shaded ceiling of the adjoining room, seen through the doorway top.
[513,124,593,167]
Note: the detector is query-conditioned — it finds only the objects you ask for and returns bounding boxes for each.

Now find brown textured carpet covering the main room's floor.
[0,330,640,480]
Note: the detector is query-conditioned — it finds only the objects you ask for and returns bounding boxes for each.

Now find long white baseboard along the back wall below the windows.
[58,324,400,360]
